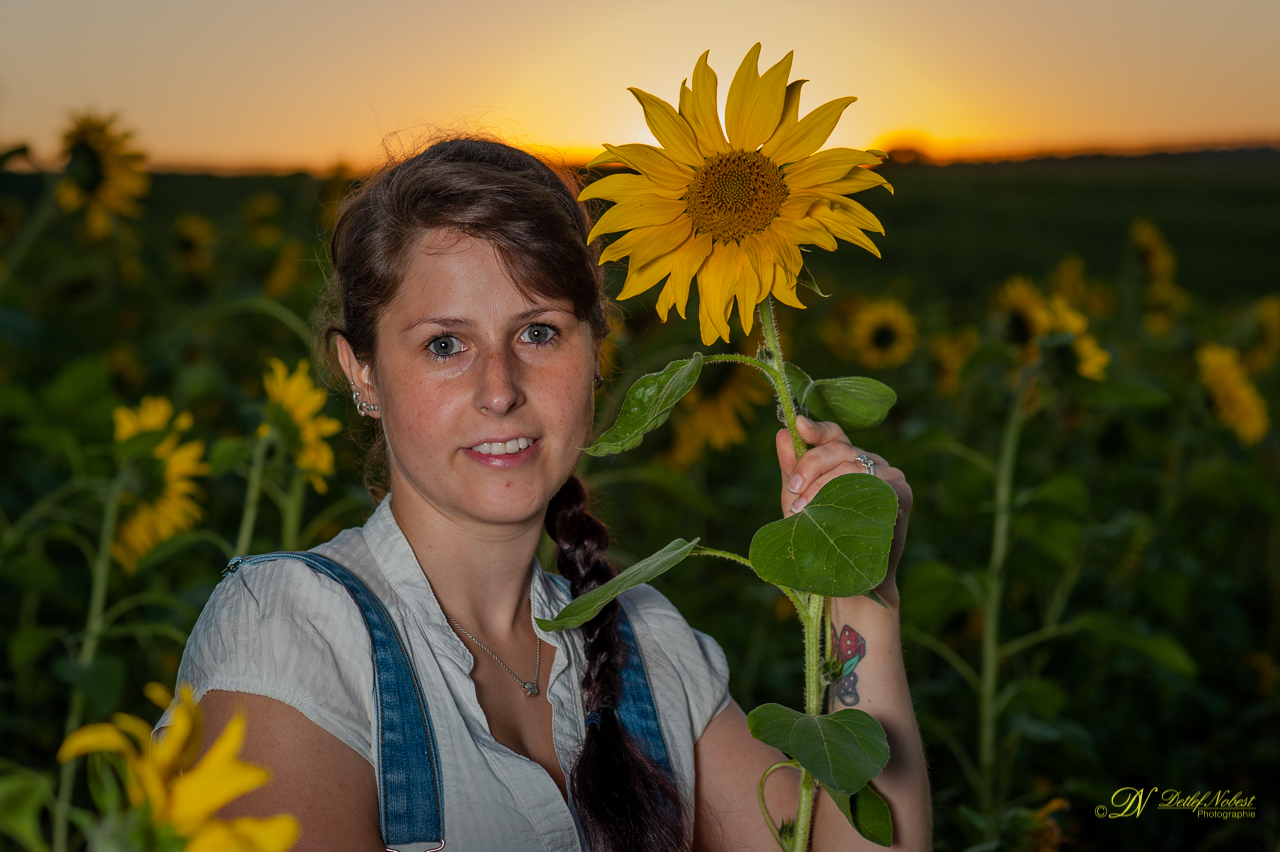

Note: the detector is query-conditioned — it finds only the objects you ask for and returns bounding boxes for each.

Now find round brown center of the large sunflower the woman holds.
[685,151,787,243]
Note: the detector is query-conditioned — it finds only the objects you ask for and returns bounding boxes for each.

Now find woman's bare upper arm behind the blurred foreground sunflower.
[200,691,385,852]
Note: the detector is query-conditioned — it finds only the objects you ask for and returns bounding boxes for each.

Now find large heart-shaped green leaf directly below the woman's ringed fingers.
[750,473,897,597]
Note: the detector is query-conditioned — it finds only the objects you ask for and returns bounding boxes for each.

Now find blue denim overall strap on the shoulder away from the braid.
[223,551,444,852]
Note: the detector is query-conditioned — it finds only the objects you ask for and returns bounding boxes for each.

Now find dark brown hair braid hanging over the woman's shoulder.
[547,476,687,852]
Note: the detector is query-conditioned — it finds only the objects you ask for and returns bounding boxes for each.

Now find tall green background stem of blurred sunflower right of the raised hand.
[978,365,1038,825]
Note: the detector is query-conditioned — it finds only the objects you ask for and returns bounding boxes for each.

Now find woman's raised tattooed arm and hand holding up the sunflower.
[694,418,933,852]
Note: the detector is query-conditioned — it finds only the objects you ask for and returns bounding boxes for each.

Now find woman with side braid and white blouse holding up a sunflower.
[167,139,929,852]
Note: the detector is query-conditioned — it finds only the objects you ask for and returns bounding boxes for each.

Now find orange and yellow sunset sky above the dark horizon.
[0,0,1280,169]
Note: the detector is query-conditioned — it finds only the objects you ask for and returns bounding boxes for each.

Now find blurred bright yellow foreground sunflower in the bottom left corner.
[58,683,300,852]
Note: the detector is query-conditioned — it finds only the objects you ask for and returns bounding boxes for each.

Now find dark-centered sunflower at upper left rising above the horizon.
[58,113,151,239]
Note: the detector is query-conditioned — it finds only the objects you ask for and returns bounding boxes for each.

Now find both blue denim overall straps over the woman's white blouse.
[223,551,675,852]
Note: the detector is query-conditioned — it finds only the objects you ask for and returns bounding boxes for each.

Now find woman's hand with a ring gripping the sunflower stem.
[777,417,911,600]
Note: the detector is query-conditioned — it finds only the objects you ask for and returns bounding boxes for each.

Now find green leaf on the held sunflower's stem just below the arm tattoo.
[746,704,888,793]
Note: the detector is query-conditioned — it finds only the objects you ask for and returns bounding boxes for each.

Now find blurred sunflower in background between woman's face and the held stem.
[666,365,771,469]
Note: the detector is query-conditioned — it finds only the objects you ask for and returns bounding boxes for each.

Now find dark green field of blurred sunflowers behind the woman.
[0,114,1280,852]
